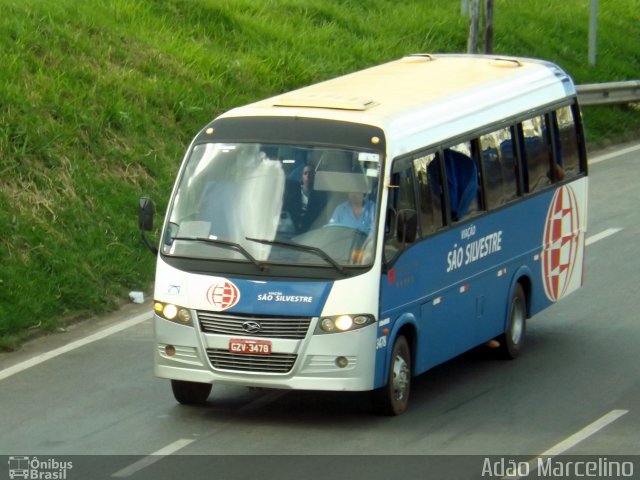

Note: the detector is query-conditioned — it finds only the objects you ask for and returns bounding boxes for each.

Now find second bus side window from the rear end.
[522,115,551,192]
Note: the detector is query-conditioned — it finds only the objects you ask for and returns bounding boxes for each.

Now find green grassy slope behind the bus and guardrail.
[0,0,640,348]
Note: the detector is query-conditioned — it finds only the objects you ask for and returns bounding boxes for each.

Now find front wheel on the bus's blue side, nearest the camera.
[373,335,411,415]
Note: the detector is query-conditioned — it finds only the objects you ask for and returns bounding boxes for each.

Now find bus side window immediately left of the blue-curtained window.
[413,153,444,236]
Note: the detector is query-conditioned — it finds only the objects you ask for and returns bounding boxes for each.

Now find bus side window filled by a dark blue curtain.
[443,142,480,222]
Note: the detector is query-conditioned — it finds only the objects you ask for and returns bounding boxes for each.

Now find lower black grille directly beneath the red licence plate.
[207,348,297,373]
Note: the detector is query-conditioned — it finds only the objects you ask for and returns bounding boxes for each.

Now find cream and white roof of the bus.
[221,54,576,154]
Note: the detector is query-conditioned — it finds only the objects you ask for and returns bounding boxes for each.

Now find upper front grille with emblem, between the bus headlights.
[198,311,311,339]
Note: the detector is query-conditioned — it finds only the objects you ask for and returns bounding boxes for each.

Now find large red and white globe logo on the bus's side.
[542,186,583,302]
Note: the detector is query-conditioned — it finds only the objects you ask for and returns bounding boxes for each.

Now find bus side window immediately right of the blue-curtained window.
[480,128,518,209]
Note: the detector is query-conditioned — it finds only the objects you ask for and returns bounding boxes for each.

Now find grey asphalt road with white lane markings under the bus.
[0,145,640,480]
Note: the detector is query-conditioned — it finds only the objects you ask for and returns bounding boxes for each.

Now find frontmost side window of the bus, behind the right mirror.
[384,158,419,261]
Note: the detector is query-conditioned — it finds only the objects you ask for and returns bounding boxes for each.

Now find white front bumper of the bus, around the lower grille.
[154,315,377,391]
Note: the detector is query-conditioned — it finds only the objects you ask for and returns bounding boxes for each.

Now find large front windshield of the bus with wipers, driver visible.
[161,143,381,271]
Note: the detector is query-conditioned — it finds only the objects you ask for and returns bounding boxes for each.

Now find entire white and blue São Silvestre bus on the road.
[139,54,587,415]
